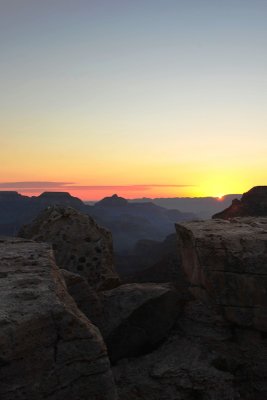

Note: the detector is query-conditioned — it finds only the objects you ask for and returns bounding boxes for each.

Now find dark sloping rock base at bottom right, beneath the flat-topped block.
[113,300,267,400]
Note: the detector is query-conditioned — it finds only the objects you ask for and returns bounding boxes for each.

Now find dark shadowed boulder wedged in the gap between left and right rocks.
[98,283,182,363]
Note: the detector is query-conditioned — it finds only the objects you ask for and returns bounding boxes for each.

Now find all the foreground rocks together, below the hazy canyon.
[0,207,267,400]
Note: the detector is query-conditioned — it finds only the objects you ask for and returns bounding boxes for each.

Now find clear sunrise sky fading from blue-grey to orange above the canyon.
[0,0,267,200]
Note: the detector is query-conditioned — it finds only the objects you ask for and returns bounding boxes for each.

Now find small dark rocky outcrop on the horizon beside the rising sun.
[215,186,267,219]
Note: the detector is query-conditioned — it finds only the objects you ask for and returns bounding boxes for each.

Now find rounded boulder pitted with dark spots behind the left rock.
[18,206,120,290]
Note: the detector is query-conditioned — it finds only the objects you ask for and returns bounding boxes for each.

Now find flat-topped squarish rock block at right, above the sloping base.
[176,218,267,332]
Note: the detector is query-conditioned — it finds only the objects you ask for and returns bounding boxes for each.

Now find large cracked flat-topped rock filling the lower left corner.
[0,239,116,400]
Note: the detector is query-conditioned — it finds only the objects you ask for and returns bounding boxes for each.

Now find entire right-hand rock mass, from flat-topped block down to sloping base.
[113,218,267,400]
